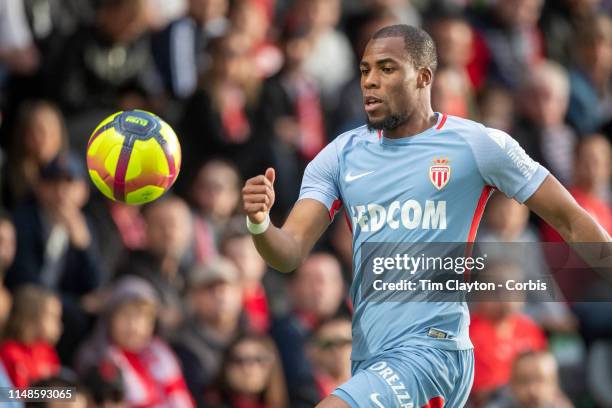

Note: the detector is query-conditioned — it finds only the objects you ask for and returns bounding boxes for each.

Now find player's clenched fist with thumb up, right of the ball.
[242,168,276,224]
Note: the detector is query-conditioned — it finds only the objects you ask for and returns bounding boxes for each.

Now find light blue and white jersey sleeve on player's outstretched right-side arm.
[470,127,549,203]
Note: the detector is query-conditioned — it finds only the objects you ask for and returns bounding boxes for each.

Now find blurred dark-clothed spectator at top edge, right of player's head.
[469,0,543,89]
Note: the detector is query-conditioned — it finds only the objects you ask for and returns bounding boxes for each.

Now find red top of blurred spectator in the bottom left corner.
[0,340,61,388]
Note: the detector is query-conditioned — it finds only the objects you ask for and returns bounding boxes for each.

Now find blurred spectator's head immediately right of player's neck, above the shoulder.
[431,67,475,118]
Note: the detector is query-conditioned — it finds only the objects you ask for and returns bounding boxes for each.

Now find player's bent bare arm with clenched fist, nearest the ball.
[242,169,330,272]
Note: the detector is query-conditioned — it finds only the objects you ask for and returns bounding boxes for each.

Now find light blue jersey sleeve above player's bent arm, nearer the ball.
[298,141,340,211]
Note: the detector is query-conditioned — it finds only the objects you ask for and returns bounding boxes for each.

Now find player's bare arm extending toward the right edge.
[525,174,612,242]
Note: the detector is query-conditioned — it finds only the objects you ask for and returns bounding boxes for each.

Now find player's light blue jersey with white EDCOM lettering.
[299,114,549,362]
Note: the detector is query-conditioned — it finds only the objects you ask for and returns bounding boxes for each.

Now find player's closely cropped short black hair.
[372,24,438,72]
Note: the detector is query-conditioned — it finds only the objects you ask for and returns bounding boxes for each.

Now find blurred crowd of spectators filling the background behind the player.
[0,0,612,408]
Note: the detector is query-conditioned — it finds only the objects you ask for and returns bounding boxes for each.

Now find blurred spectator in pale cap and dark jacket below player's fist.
[173,258,246,406]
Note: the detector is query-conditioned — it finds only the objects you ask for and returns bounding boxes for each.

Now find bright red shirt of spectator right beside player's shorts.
[470,313,547,393]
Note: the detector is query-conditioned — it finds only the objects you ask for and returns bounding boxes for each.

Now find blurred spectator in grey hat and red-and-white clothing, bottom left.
[77,276,194,408]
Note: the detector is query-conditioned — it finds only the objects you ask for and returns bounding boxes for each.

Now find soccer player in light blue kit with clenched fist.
[242,25,610,408]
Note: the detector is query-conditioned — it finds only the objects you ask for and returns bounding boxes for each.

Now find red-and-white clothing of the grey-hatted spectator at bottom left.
[100,339,194,408]
